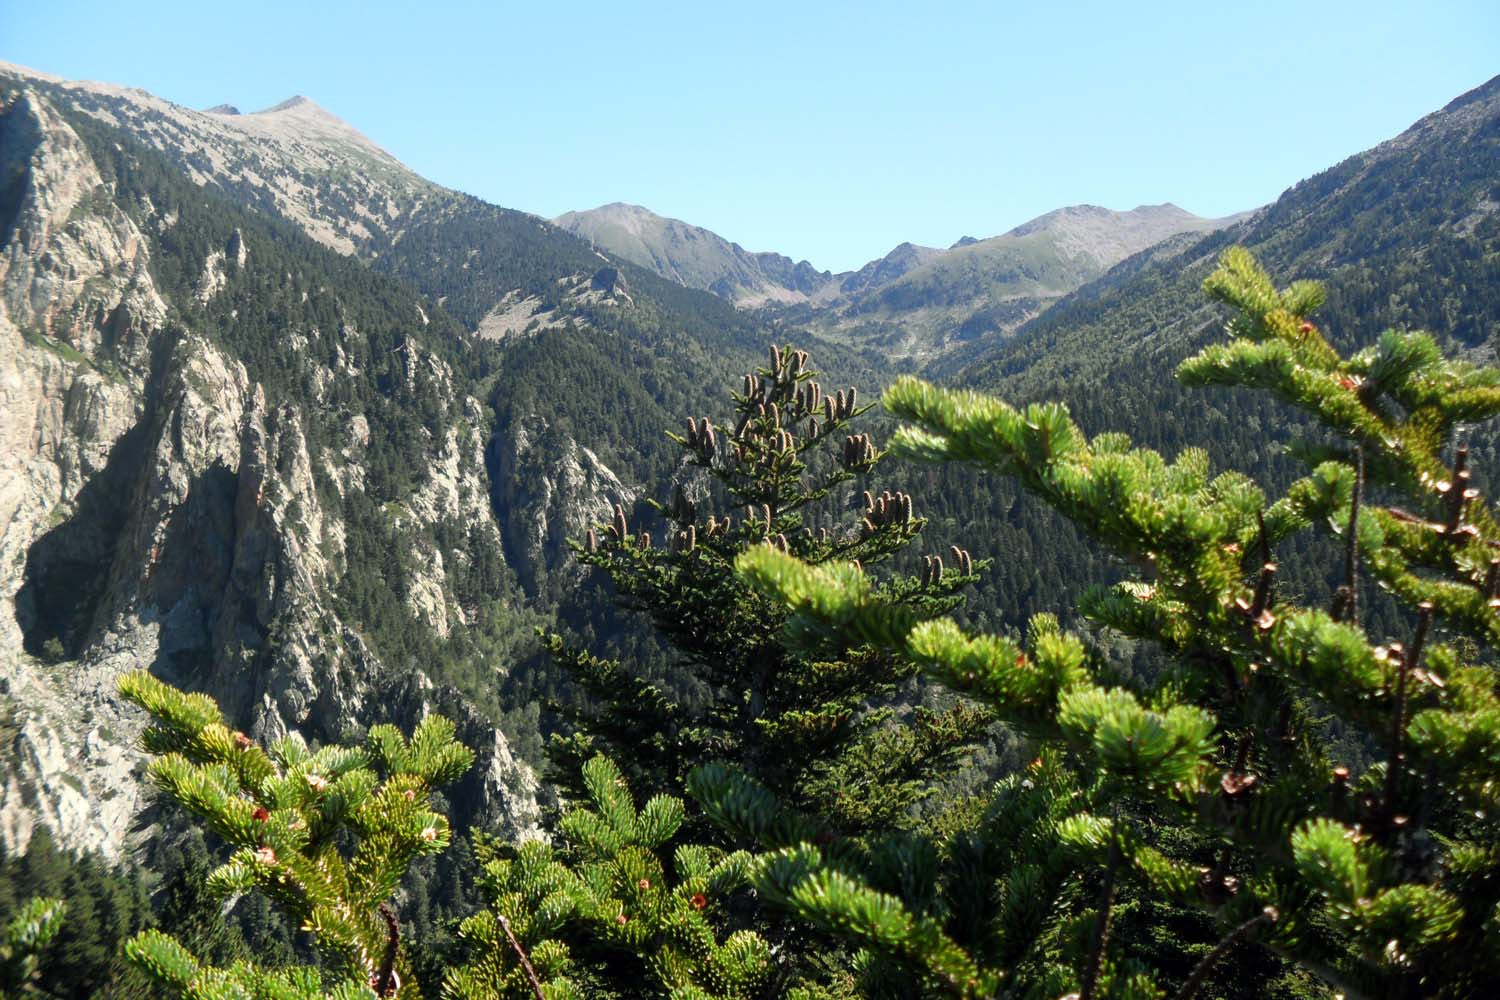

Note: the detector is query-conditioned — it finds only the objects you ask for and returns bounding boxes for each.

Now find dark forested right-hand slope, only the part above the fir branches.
[960,78,1500,444]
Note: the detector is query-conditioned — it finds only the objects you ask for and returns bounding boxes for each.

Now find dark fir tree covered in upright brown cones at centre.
[546,346,989,835]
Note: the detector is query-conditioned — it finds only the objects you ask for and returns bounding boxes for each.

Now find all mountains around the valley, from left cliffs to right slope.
[0,64,1500,855]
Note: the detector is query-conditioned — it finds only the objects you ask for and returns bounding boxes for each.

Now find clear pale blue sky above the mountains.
[0,0,1500,270]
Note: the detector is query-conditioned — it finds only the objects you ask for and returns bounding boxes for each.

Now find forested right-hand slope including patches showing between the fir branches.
[918,79,1500,641]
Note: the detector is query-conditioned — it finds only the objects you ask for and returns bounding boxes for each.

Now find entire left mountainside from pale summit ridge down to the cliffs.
[0,67,875,852]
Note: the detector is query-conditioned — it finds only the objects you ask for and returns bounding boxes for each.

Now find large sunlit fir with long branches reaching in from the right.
[711,249,1500,1000]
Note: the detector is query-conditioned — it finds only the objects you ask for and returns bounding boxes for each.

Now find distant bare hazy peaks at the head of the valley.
[554,202,1248,364]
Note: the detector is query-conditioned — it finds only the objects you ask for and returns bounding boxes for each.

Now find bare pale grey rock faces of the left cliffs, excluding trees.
[0,91,537,855]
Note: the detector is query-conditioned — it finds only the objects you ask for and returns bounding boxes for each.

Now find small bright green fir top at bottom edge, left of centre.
[444,757,798,1000]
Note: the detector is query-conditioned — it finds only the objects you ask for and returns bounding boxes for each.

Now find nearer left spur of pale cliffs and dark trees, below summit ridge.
[0,88,564,850]
